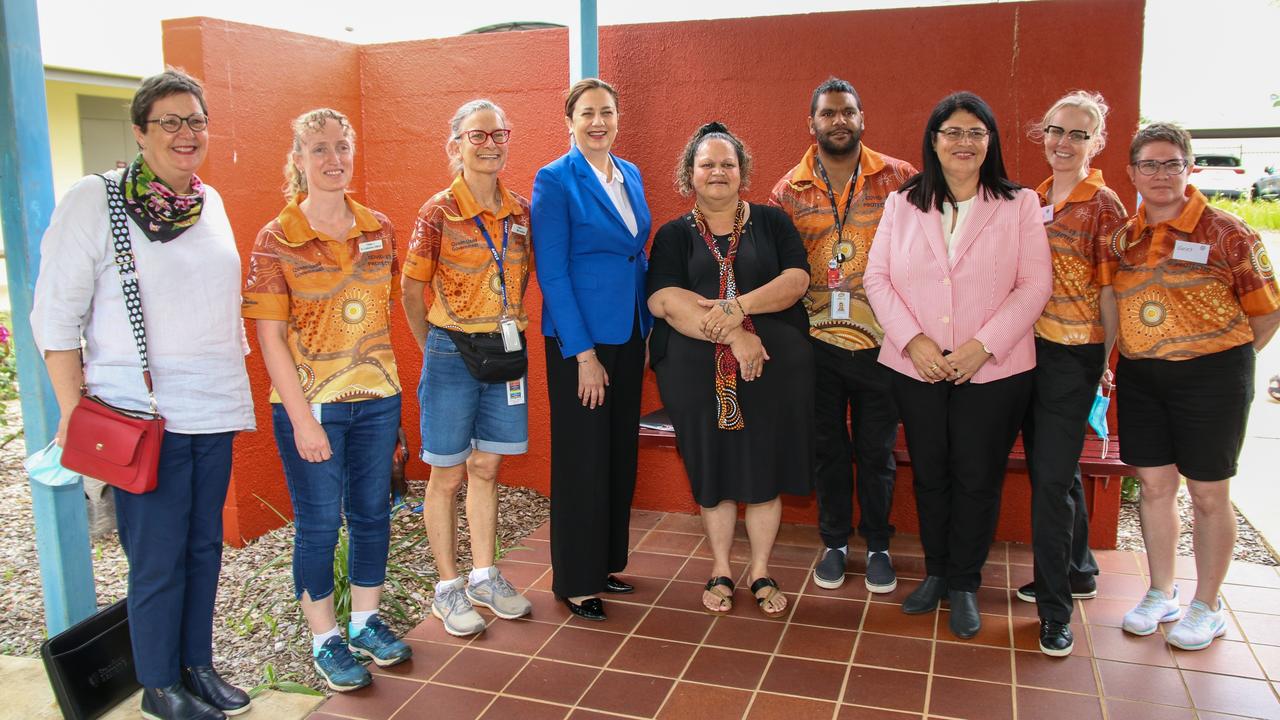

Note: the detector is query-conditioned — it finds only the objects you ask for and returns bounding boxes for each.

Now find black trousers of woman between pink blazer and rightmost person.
[1023,338,1106,623]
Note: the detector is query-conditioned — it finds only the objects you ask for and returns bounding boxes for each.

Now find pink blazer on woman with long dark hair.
[863,190,1053,383]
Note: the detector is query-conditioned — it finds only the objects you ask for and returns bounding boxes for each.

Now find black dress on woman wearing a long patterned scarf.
[648,205,814,507]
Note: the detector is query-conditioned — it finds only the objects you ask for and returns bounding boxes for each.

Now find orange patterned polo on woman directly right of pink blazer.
[1036,169,1128,345]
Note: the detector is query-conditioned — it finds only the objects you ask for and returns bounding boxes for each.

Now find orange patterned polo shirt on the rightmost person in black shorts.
[1111,186,1280,360]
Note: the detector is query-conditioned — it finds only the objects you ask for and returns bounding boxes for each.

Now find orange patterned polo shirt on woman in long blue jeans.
[242,193,401,402]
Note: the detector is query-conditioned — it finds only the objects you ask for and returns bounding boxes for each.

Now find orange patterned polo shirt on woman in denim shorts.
[404,174,532,333]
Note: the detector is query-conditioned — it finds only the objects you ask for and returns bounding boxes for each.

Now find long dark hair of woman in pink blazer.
[900,92,1021,213]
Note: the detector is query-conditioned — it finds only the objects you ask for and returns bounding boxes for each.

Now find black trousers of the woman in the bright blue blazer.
[545,323,644,597]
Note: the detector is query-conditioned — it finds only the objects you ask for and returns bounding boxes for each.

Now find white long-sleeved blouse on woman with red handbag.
[31,170,255,434]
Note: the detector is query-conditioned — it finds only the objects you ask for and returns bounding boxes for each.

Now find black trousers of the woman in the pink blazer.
[892,370,1032,592]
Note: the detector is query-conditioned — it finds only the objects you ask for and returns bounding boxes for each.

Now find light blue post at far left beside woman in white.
[0,0,97,635]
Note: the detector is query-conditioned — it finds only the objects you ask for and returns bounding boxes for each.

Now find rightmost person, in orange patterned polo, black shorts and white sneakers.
[1111,123,1280,650]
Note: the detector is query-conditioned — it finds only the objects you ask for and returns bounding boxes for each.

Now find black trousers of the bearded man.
[810,338,897,552]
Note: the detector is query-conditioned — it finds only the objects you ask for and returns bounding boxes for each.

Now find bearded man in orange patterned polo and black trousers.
[769,77,915,593]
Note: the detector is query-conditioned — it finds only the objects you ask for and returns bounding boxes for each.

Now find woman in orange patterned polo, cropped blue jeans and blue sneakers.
[243,108,412,692]
